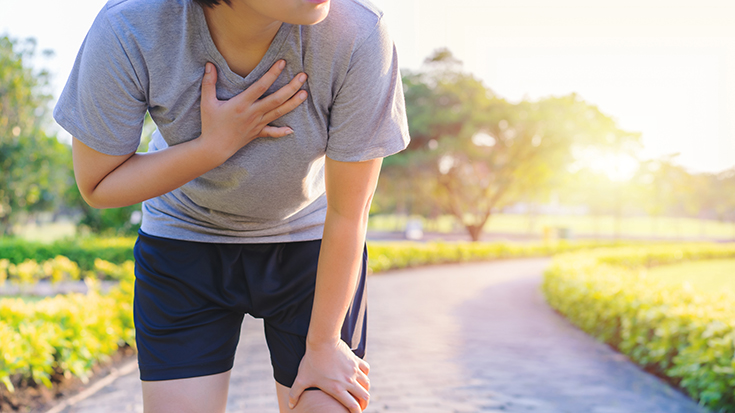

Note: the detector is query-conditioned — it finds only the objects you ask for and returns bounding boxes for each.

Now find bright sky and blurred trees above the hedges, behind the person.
[0,0,735,240]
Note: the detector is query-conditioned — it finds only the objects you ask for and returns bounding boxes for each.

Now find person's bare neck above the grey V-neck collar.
[203,1,282,52]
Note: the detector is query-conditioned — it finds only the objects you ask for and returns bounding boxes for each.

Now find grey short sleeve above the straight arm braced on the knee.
[327,19,409,162]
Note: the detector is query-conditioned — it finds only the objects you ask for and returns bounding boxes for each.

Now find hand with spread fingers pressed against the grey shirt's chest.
[199,60,307,162]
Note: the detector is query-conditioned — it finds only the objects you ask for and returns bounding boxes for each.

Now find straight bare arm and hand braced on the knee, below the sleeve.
[290,158,382,413]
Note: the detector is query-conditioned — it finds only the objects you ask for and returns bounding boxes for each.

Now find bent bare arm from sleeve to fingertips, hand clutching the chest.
[72,61,306,208]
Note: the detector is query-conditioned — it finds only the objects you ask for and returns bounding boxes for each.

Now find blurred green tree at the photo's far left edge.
[0,36,71,235]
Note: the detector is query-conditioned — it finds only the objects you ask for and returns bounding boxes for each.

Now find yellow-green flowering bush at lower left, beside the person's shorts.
[0,260,135,390]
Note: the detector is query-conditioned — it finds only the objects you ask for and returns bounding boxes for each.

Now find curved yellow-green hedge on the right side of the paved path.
[542,244,735,412]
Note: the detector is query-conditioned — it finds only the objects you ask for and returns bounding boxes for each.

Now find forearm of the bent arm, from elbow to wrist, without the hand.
[80,138,224,208]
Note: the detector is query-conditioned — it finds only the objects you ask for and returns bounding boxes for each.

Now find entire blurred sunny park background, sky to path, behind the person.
[0,0,735,412]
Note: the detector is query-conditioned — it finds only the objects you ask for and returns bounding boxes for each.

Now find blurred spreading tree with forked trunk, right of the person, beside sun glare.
[396,49,639,240]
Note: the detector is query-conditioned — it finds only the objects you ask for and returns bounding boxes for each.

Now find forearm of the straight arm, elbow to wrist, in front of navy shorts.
[307,209,367,346]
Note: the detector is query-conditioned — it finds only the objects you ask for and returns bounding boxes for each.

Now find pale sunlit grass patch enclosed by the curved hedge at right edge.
[647,259,735,293]
